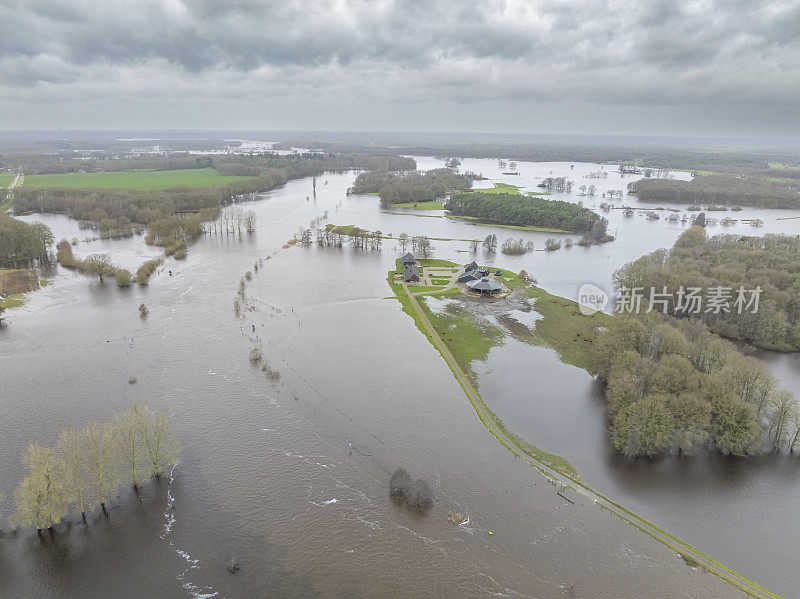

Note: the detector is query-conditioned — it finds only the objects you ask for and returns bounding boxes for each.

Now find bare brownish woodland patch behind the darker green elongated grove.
[351,168,473,205]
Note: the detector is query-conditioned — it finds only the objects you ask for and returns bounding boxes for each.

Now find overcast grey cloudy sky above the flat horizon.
[0,0,800,137]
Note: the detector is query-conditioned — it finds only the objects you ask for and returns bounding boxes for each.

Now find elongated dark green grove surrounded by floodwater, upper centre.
[445,193,600,231]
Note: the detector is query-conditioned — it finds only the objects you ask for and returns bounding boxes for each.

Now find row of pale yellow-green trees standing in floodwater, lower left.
[13,403,180,534]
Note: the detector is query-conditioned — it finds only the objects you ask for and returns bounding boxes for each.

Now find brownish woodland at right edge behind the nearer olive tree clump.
[614,226,800,351]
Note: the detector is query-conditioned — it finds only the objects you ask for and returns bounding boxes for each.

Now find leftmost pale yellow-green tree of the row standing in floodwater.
[14,441,66,534]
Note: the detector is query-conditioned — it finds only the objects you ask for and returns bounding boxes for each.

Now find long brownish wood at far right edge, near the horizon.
[628,175,800,208]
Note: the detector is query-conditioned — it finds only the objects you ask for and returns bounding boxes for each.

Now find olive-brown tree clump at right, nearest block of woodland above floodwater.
[593,313,800,457]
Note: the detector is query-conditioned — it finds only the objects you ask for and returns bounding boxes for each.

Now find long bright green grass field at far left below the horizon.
[23,168,248,190]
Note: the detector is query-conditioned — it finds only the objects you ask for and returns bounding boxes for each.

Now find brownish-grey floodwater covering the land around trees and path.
[0,159,798,597]
